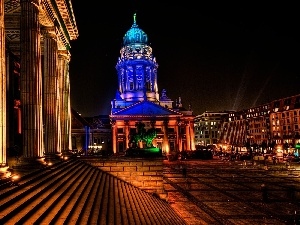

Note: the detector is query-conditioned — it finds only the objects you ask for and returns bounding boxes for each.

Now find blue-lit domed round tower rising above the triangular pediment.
[112,14,173,112]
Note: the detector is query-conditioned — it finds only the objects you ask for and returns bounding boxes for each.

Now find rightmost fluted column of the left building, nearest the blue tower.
[58,50,72,154]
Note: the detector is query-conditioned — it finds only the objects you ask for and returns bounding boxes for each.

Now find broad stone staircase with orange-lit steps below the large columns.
[0,159,186,225]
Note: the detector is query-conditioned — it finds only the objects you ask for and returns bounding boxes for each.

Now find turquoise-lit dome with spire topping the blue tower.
[123,13,148,46]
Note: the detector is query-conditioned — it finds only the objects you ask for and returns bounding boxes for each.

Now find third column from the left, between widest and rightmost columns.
[42,27,60,160]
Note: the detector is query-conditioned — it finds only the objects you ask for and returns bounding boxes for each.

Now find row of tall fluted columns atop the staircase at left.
[0,0,72,166]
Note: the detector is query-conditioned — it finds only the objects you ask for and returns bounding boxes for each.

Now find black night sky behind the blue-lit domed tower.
[70,0,300,116]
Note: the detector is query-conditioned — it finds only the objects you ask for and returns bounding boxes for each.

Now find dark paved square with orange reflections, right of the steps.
[164,159,300,225]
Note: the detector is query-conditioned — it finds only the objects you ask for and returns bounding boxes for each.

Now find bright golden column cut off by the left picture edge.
[0,1,7,167]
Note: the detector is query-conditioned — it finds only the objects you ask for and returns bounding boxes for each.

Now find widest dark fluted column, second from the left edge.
[20,0,44,162]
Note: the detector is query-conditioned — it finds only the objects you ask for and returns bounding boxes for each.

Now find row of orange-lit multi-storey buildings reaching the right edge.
[218,94,300,155]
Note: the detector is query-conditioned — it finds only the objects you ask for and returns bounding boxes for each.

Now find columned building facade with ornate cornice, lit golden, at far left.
[0,0,78,171]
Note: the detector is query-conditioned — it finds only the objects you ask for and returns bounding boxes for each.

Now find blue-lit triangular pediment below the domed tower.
[112,101,182,117]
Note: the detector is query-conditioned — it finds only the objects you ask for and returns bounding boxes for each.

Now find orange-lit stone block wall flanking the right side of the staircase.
[81,157,167,200]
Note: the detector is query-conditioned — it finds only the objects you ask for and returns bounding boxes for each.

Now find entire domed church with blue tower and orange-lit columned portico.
[110,14,195,154]
